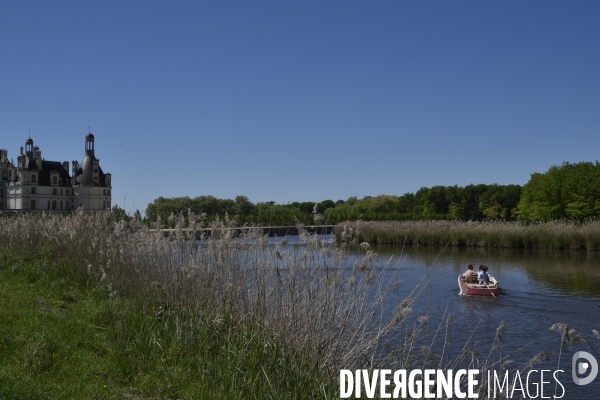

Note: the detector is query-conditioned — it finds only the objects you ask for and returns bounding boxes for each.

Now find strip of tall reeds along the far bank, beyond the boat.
[335,220,600,251]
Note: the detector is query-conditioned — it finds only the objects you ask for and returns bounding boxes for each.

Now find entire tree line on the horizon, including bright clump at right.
[145,162,600,226]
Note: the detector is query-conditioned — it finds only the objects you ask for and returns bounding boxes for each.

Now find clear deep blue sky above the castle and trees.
[0,0,600,211]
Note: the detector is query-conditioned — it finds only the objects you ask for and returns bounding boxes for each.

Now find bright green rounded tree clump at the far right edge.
[517,162,600,221]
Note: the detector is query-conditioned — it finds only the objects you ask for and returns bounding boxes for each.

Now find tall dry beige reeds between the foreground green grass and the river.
[0,212,405,380]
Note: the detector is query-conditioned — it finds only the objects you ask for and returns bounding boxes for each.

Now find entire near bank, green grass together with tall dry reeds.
[0,212,580,399]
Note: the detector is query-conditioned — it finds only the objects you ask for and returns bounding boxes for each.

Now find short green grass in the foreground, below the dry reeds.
[0,252,336,399]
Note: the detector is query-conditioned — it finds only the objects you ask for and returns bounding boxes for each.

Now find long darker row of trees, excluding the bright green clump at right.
[146,184,524,228]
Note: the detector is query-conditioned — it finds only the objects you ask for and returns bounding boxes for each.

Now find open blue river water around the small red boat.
[271,236,600,400]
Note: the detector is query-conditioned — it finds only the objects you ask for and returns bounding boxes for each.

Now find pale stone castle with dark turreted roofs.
[0,132,111,214]
